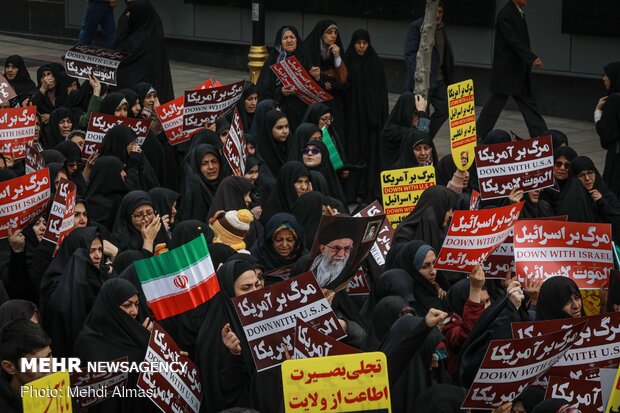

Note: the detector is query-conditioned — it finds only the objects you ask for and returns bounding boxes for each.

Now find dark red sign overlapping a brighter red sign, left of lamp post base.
[183,80,245,131]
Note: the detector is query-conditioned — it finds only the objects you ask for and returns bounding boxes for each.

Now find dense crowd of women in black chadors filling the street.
[0,0,620,413]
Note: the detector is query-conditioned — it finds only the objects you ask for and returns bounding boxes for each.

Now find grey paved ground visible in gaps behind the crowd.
[0,36,605,172]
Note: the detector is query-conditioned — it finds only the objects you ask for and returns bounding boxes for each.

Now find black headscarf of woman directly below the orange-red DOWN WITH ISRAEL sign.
[536,277,585,321]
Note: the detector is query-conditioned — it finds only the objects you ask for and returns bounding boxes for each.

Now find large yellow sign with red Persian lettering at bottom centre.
[282,352,392,413]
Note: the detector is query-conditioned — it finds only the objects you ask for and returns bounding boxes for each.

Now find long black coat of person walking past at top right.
[490,1,537,96]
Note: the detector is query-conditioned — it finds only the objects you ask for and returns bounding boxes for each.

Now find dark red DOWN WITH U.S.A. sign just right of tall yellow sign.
[476,136,555,199]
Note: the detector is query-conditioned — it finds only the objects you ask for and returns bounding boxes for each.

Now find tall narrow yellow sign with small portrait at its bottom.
[448,79,476,171]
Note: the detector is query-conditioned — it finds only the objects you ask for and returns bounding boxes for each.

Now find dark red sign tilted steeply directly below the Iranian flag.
[136,323,202,413]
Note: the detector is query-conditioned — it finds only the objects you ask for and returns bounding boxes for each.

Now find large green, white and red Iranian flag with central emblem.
[135,234,220,320]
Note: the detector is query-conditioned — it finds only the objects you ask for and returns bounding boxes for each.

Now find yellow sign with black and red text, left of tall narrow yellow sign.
[381,166,435,228]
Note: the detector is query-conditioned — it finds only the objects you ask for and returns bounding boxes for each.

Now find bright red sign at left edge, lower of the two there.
[0,168,50,239]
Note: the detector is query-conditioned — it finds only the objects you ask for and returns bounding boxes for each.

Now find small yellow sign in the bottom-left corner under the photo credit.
[21,371,73,413]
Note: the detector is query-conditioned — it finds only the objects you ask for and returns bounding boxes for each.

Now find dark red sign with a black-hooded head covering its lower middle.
[82,113,151,159]
